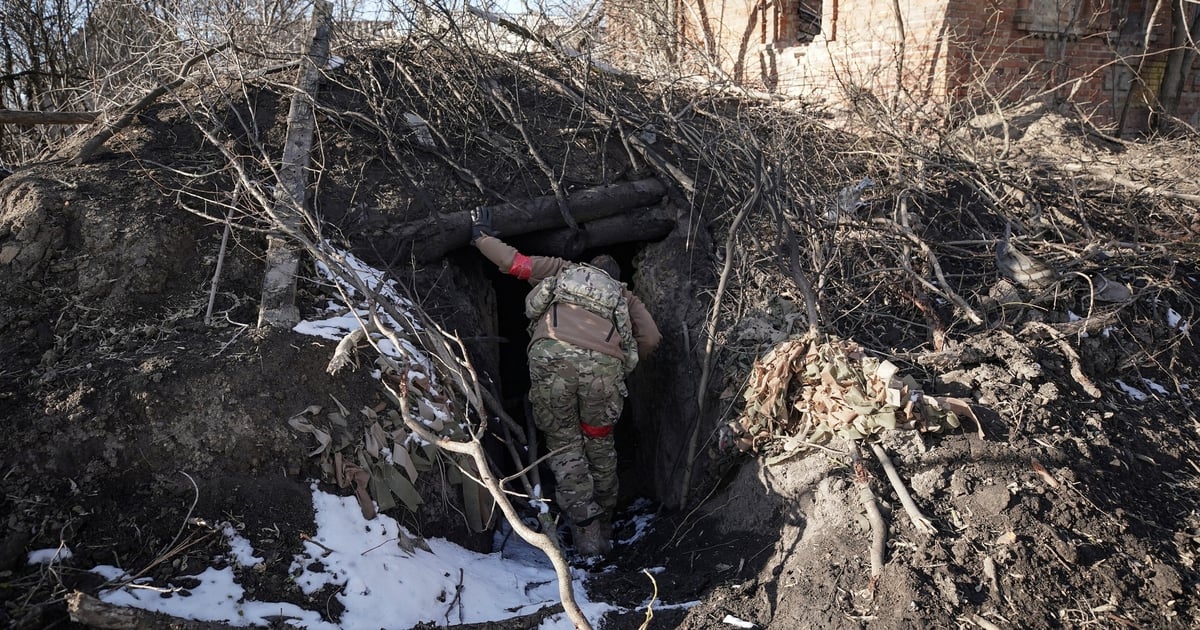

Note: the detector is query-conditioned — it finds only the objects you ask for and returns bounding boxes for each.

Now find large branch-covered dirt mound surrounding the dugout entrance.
[0,39,1200,629]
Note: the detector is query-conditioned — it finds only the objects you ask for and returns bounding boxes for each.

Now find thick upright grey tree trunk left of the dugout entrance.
[258,0,334,328]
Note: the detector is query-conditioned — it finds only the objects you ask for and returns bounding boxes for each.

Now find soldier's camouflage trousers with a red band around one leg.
[529,338,628,523]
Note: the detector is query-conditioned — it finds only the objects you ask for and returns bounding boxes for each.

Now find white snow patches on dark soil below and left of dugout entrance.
[21,246,696,630]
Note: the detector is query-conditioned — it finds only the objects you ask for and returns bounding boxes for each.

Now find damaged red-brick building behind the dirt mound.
[607,0,1200,130]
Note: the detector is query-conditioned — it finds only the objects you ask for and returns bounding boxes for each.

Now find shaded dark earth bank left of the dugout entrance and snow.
[0,152,355,628]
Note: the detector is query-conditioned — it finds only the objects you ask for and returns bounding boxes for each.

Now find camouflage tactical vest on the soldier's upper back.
[526,263,637,373]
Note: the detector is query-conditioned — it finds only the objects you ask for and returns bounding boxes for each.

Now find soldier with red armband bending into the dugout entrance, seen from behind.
[472,208,661,556]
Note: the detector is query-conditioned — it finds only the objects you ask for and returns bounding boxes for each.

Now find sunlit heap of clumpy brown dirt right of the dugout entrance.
[619,314,1200,628]
